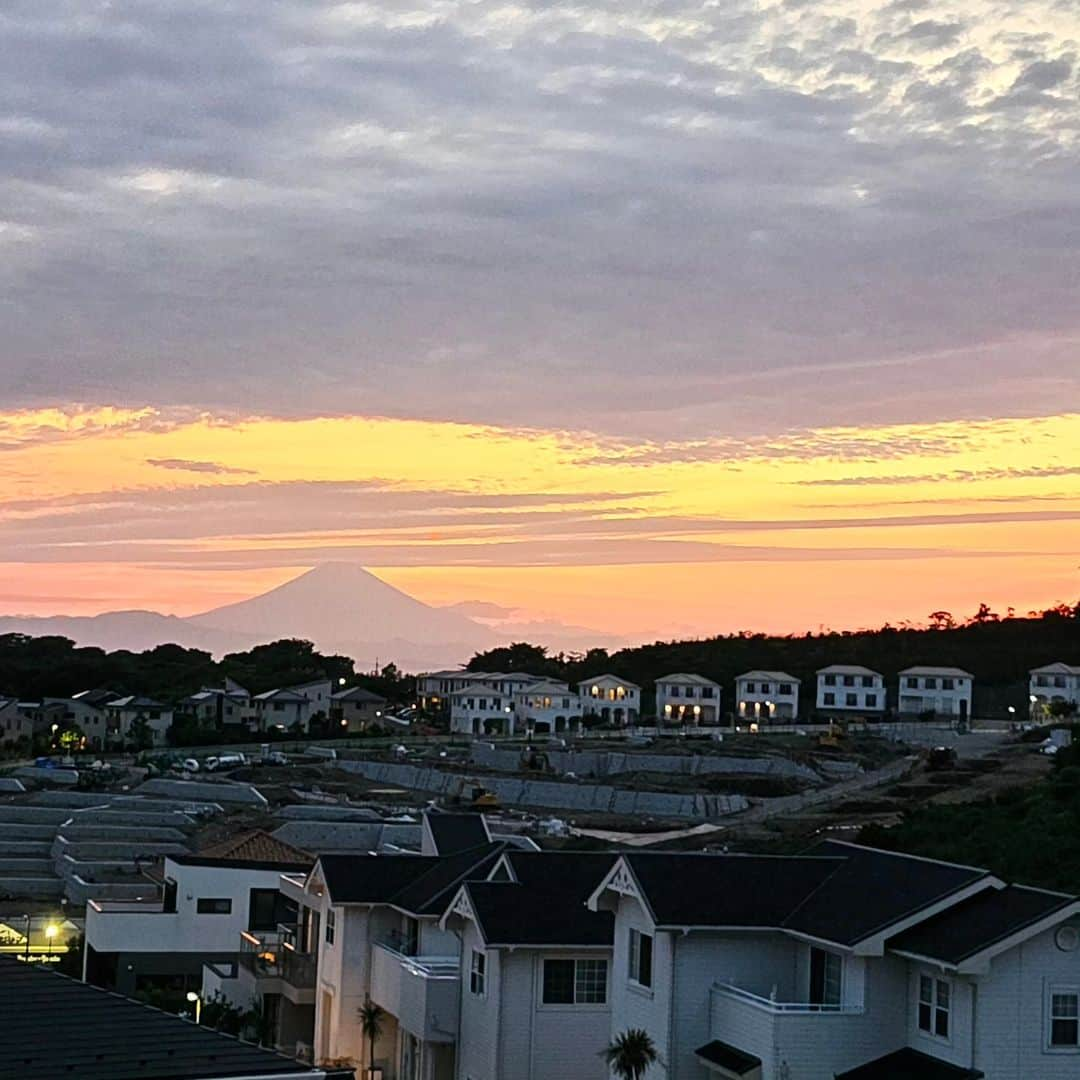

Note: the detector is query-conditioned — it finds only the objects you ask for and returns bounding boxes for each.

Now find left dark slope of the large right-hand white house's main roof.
[624,851,843,927]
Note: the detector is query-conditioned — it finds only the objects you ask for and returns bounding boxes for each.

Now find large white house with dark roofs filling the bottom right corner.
[589,841,1080,1080]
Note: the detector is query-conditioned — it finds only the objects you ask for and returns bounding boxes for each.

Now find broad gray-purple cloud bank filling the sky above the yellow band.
[0,0,1080,435]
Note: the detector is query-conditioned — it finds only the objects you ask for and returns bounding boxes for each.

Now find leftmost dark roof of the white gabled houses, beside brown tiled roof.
[319,843,504,915]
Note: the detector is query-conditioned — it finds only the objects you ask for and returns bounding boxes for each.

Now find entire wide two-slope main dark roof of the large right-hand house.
[623,840,988,945]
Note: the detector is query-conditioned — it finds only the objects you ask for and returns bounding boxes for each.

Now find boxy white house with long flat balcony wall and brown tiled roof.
[83,832,313,996]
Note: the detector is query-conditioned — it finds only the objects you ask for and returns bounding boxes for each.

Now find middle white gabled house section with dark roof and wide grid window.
[441,851,613,1080]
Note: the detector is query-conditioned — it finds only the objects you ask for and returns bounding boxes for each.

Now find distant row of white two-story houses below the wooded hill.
[417,663,1080,735]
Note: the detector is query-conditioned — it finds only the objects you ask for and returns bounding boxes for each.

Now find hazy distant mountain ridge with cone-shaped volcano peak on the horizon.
[0,563,613,671]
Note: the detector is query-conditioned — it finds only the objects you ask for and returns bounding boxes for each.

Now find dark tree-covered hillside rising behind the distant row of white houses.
[469,604,1080,715]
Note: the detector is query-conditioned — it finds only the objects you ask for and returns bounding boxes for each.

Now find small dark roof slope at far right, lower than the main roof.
[889,885,1077,963]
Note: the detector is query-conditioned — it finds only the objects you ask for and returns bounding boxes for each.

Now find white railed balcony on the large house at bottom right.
[710,983,868,1078]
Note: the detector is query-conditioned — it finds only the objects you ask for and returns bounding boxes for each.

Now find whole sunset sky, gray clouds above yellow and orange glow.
[0,0,1080,638]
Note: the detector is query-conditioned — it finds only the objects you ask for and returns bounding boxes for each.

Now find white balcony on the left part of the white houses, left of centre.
[372,945,461,1042]
